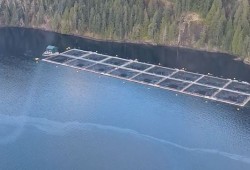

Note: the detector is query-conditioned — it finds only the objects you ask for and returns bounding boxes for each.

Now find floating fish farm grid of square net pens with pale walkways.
[43,49,250,107]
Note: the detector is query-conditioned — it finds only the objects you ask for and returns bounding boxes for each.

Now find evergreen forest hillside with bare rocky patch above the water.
[0,0,250,57]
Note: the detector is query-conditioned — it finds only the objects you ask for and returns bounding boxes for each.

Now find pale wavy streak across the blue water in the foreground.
[0,115,250,164]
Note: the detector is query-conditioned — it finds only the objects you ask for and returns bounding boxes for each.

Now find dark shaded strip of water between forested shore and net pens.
[0,28,250,83]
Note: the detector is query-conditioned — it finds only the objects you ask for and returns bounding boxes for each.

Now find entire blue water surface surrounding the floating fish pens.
[0,28,250,170]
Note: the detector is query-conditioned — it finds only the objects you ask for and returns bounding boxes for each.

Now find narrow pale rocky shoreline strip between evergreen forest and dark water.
[0,25,250,65]
